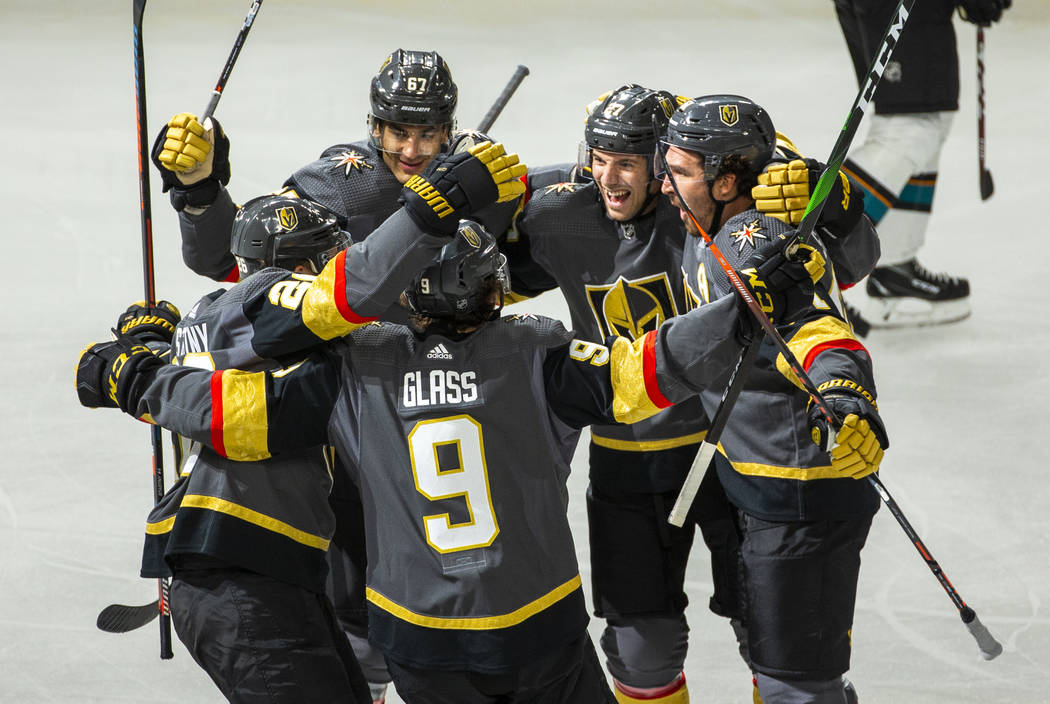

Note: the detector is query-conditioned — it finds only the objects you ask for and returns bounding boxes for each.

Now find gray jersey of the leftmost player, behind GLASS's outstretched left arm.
[142,269,335,593]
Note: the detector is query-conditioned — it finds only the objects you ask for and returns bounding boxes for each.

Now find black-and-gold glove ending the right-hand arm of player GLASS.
[737,233,824,334]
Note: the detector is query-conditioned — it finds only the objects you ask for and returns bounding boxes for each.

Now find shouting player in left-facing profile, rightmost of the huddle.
[663,95,888,704]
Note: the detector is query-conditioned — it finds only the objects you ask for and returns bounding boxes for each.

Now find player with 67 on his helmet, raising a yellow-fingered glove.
[153,49,517,701]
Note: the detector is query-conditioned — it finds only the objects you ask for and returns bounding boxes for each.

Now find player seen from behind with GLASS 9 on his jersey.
[80,211,814,704]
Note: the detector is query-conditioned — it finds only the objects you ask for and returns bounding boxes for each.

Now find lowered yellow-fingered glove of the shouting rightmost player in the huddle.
[810,388,889,479]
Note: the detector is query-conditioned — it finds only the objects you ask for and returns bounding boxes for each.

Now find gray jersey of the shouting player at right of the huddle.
[683,209,879,520]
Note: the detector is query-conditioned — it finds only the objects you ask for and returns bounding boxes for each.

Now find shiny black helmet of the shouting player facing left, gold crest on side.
[664,95,777,181]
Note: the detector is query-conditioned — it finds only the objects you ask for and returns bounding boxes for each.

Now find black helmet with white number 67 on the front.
[369,49,459,131]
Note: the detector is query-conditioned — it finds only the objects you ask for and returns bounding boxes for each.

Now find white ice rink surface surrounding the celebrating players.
[0,0,1050,704]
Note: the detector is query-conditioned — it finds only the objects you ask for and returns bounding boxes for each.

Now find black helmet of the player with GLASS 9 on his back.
[405,220,510,319]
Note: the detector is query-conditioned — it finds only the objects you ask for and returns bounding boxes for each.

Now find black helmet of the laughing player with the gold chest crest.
[584,83,678,156]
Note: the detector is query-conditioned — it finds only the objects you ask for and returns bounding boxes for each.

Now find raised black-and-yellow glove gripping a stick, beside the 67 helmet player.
[150,112,230,212]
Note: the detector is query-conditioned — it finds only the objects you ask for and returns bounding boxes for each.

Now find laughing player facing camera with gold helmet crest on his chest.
[507,84,878,704]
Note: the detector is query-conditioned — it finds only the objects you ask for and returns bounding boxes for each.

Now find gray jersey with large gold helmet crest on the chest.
[507,183,708,491]
